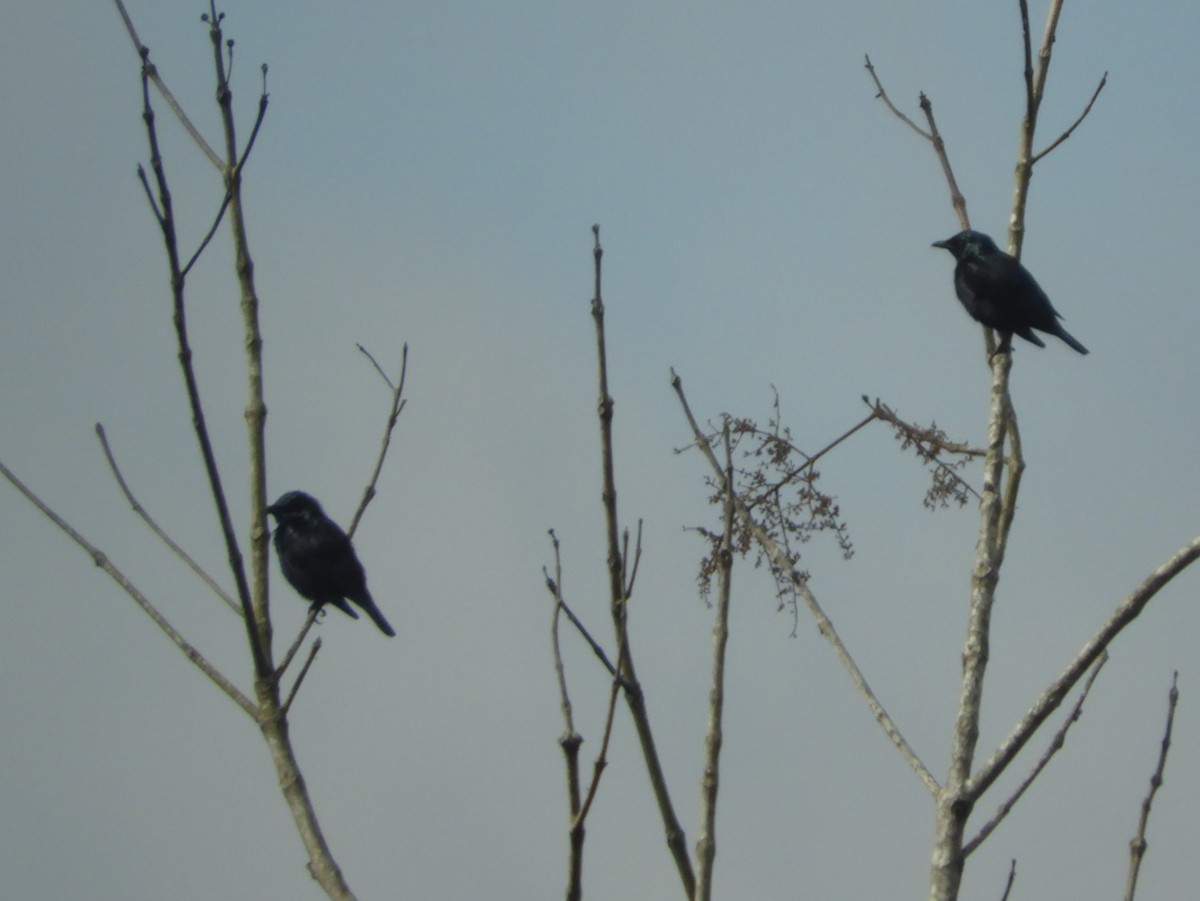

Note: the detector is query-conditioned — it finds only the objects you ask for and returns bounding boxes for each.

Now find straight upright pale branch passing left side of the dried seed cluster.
[695,420,736,901]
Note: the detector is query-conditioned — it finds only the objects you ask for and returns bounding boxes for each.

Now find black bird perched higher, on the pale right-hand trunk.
[934,230,1087,354]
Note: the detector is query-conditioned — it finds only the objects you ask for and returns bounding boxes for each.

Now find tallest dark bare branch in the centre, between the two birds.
[592,226,696,899]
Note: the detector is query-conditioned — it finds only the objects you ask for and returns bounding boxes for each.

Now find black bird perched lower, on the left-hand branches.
[266,491,396,636]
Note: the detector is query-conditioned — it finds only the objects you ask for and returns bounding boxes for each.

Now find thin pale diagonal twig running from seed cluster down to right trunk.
[671,370,940,794]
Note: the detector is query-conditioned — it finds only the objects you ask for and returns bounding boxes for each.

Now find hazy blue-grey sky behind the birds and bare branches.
[0,0,1200,901]
